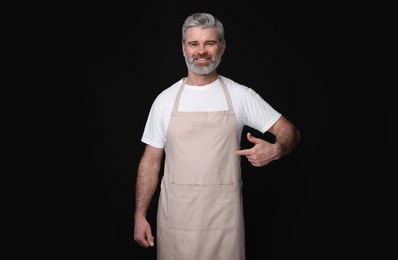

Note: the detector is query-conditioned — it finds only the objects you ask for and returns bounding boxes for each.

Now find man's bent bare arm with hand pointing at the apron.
[236,116,300,167]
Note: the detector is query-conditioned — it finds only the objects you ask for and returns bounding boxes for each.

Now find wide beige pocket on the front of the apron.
[167,184,236,230]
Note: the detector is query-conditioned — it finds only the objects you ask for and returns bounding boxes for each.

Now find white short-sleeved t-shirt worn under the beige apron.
[141,76,281,148]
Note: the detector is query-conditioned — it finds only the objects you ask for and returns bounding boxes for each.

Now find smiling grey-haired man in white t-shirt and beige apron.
[134,13,300,260]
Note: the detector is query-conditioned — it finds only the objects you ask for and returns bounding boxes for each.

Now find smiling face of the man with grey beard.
[182,27,225,75]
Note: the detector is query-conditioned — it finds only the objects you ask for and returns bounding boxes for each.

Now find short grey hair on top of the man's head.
[182,13,225,43]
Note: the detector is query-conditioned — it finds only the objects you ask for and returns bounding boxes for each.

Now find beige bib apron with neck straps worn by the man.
[157,77,245,260]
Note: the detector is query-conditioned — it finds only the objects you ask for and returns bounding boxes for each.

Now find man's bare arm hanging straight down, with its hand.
[134,145,164,247]
